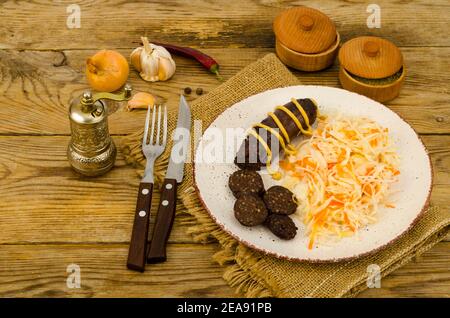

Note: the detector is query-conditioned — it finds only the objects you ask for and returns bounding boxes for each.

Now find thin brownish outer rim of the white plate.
[192,85,434,264]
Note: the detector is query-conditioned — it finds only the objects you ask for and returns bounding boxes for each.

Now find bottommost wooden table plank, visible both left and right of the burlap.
[0,242,450,297]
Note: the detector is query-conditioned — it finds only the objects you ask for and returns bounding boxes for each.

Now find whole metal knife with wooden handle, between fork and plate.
[147,95,191,263]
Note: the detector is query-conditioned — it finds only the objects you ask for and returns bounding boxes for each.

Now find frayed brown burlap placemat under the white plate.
[122,54,450,297]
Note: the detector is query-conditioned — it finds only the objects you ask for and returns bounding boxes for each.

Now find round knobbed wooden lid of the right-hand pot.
[339,36,403,78]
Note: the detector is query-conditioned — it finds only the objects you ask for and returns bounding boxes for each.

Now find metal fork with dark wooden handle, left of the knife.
[127,105,167,272]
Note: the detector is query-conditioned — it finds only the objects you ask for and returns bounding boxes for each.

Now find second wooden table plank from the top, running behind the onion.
[0,48,450,134]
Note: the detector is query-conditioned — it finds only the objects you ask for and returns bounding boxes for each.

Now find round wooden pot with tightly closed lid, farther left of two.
[273,7,340,72]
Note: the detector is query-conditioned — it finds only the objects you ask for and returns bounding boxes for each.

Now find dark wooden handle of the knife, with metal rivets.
[147,179,177,263]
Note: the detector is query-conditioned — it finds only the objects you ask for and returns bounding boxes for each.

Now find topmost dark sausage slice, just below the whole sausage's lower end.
[228,170,264,198]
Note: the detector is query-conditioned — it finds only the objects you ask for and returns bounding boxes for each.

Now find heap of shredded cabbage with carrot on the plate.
[280,116,400,249]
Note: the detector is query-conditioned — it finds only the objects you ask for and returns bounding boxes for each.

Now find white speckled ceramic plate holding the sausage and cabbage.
[194,86,432,262]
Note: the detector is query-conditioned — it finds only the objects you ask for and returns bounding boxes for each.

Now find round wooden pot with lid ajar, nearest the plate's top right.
[339,36,406,102]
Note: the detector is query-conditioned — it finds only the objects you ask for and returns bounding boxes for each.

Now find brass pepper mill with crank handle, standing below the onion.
[67,84,131,176]
